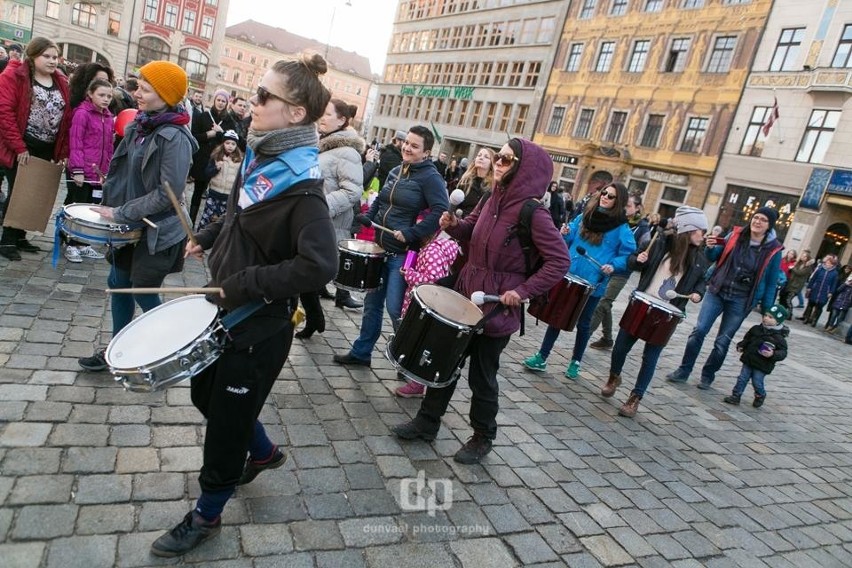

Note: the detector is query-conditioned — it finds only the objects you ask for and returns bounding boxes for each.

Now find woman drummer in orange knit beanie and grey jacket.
[77,61,197,371]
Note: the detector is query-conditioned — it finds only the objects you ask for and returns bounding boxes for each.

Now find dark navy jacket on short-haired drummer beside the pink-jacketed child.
[367,155,450,254]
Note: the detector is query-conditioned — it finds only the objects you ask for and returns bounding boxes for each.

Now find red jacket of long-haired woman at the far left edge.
[0,63,71,168]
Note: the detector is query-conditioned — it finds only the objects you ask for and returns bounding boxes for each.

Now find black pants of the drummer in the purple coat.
[416,335,511,440]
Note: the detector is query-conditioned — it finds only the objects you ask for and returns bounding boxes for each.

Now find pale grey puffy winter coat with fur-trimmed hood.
[319,129,367,240]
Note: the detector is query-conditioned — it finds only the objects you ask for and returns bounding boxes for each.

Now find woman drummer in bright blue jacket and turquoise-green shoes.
[524,182,636,379]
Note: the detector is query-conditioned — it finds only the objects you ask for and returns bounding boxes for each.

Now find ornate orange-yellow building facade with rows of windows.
[535,0,772,217]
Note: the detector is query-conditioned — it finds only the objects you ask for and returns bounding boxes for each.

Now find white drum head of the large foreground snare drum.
[105,294,219,369]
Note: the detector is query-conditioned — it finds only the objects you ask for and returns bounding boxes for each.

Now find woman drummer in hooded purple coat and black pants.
[392,138,570,464]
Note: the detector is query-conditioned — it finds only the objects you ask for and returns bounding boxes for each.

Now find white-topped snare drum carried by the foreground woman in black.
[104,294,223,392]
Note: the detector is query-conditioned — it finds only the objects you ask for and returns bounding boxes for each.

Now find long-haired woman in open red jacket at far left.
[0,37,71,260]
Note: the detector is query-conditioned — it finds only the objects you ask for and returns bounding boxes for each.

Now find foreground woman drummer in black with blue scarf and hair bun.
[151,54,337,557]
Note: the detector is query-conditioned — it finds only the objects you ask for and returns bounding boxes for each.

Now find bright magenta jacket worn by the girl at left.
[68,99,115,183]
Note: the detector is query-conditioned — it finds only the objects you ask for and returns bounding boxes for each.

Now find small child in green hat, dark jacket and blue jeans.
[723,304,790,408]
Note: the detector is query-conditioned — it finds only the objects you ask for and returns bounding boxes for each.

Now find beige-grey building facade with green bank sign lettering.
[369,0,571,163]
